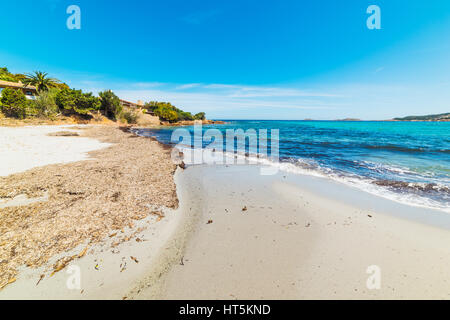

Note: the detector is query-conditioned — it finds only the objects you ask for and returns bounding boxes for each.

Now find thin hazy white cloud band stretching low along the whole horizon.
[70,78,450,119]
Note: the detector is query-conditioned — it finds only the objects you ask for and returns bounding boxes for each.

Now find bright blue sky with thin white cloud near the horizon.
[0,0,450,120]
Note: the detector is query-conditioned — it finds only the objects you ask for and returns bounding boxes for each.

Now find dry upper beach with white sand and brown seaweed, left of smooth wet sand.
[0,126,178,299]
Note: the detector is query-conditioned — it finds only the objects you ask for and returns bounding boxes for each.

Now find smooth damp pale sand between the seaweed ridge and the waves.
[147,166,450,299]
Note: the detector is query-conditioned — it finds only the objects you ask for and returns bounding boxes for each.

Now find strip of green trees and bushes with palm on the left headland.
[0,67,206,124]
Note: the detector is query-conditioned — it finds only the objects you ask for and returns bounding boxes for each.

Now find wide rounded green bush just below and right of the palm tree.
[55,89,101,116]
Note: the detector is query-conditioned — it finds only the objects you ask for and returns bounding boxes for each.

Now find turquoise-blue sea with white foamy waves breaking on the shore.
[138,120,450,211]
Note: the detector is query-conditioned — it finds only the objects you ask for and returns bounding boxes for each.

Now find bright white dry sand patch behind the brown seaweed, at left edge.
[0,125,109,176]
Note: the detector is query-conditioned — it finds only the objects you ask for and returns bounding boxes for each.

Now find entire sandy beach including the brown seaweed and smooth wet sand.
[0,126,450,299]
